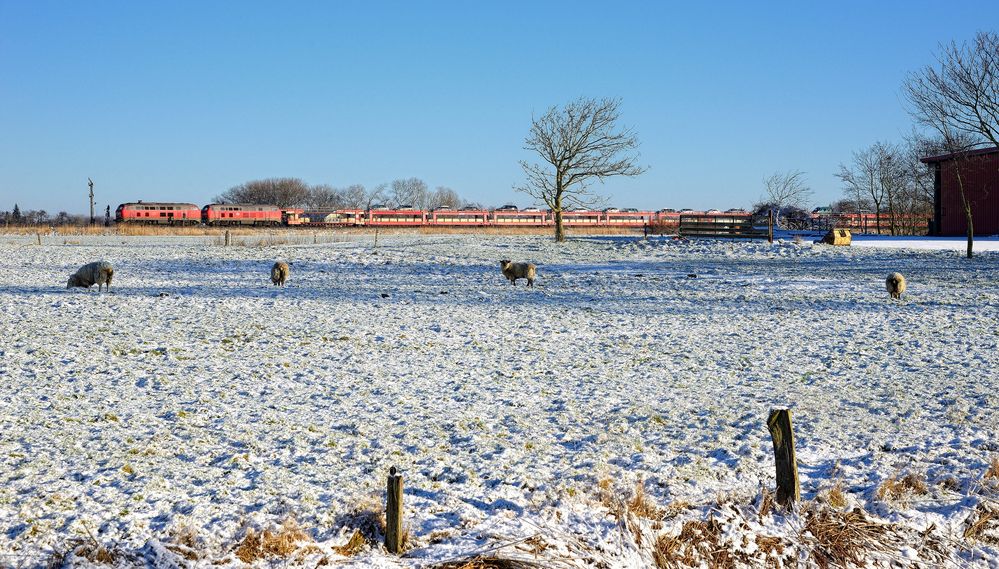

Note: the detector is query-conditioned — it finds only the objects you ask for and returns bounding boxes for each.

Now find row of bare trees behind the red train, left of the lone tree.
[215,178,478,210]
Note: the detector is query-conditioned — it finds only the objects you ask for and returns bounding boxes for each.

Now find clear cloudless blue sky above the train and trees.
[0,0,999,213]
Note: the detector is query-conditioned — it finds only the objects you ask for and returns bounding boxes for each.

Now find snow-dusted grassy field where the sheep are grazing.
[0,235,999,568]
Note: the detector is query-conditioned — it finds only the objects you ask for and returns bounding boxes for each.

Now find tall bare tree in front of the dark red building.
[903,28,999,258]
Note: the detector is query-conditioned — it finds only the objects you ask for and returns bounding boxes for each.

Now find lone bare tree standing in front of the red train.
[517,98,646,241]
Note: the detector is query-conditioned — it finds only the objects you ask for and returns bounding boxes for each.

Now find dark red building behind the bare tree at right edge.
[922,148,999,236]
